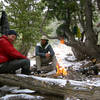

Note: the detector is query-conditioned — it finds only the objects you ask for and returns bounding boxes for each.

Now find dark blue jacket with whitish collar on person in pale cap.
[35,43,54,57]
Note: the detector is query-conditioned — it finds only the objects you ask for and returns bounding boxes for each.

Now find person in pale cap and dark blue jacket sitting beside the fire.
[35,36,56,73]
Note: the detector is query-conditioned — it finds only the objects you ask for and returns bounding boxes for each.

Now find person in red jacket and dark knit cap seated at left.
[0,30,30,74]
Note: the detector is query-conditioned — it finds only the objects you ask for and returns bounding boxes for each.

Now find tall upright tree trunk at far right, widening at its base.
[85,0,100,58]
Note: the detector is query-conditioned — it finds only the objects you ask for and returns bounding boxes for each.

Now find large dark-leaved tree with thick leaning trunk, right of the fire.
[42,0,100,60]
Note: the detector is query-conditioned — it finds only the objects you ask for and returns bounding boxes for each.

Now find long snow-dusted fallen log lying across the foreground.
[0,74,100,100]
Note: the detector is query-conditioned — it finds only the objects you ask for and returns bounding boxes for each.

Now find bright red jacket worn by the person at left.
[0,35,26,63]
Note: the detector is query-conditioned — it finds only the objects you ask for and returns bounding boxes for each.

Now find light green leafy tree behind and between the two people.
[4,0,46,55]
